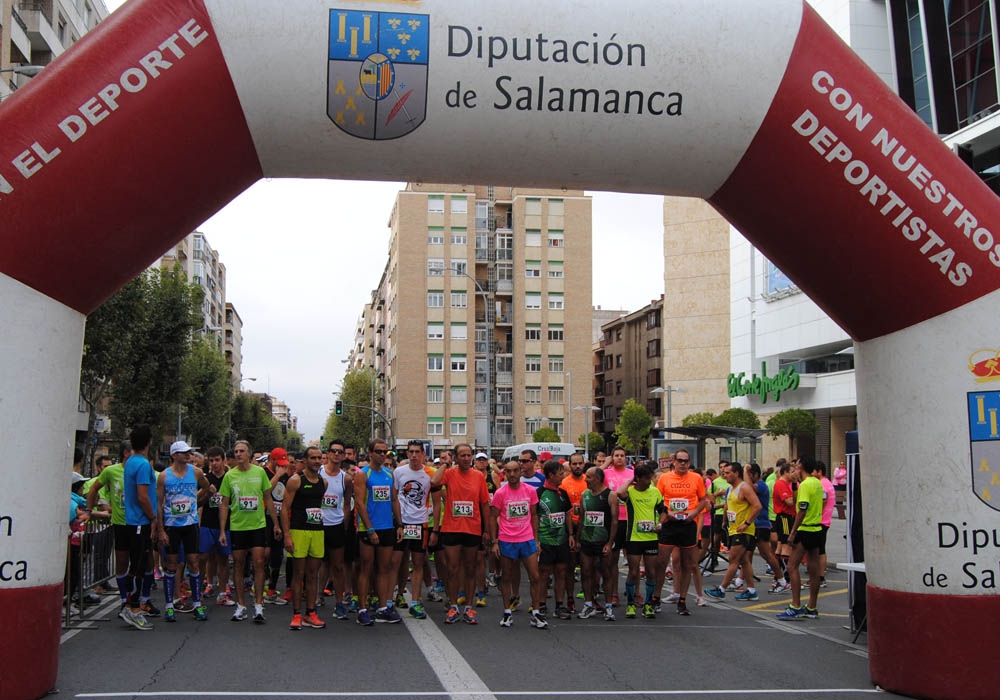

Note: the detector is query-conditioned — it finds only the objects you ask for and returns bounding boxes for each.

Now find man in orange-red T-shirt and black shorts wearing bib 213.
[431,443,490,625]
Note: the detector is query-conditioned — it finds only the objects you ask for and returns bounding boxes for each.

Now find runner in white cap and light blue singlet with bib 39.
[156,440,209,622]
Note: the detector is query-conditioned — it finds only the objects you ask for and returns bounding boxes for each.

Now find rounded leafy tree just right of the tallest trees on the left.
[183,338,232,447]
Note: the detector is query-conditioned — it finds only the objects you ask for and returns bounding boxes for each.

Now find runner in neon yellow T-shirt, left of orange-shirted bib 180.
[605,464,667,619]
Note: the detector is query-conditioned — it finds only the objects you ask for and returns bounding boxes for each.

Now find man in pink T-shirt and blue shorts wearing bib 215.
[490,461,549,629]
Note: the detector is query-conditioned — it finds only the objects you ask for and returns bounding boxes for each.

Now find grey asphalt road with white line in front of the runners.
[50,521,899,700]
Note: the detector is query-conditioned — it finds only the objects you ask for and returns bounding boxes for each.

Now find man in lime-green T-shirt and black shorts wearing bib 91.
[219,440,281,625]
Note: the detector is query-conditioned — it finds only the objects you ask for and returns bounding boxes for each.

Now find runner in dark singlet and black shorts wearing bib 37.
[577,467,619,622]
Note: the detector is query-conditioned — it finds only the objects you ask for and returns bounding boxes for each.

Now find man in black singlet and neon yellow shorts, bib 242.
[281,447,327,630]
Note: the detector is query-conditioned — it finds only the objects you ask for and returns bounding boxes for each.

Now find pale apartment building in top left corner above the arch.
[0,0,108,100]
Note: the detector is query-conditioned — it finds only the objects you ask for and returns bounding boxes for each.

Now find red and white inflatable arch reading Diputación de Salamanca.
[0,0,1000,699]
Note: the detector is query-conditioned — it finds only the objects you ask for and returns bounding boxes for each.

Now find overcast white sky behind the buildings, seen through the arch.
[105,0,663,440]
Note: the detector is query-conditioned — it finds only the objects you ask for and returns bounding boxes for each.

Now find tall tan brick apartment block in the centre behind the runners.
[368,184,593,450]
